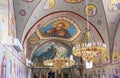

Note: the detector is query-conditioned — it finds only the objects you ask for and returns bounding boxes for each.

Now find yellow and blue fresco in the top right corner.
[108,0,120,12]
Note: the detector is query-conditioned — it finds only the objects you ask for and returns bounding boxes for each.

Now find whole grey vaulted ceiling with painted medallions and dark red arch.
[14,0,120,65]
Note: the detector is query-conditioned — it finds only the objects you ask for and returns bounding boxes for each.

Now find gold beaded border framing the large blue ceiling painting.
[35,17,81,41]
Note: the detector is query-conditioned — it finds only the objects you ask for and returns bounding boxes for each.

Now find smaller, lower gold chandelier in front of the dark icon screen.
[43,52,75,73]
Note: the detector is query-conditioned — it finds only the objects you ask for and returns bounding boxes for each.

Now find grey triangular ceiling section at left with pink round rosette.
[13,0,41,39]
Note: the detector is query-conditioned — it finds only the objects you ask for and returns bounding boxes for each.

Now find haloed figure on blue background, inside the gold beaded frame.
[40,20,76,38]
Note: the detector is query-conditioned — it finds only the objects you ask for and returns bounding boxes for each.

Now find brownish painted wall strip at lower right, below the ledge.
[84,64,120,78]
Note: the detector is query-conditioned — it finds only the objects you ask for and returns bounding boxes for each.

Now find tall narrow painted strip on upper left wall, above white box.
[8,0,16,37]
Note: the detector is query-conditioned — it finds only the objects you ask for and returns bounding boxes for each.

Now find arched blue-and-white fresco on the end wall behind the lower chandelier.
[32,41,71,62]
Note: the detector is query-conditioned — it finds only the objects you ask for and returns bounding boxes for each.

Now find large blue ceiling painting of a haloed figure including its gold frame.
[36,17,81,41]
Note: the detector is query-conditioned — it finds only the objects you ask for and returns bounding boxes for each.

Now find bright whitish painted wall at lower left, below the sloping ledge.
[0,45,27,78]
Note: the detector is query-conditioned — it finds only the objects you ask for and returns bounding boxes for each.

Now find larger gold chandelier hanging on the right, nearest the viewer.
[72,30,106,62]
